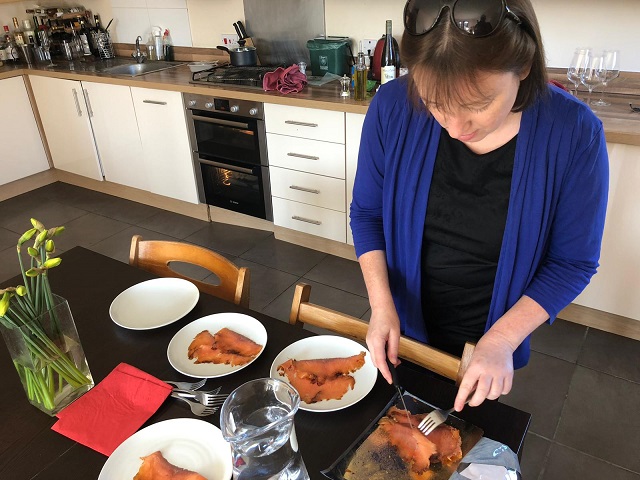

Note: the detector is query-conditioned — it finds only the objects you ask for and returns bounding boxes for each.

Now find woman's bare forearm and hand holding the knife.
[358,250,400,383]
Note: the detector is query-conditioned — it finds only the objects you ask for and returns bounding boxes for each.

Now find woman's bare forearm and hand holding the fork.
[454,296,549,412]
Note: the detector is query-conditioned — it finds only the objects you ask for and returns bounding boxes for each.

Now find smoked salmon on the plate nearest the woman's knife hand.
[278,352,365,404]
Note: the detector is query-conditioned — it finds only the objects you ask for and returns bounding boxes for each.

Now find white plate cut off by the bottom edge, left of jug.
[98,418,232,480]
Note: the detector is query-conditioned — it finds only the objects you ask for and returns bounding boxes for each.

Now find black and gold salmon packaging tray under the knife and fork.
[322,392,484,480]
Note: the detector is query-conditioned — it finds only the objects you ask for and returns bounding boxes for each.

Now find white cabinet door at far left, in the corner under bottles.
[0,77,49,185]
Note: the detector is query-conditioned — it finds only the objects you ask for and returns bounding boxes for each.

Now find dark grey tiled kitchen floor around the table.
[0,183,640,480]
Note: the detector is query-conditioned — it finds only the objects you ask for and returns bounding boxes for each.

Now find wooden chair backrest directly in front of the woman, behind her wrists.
[289,283,475,384]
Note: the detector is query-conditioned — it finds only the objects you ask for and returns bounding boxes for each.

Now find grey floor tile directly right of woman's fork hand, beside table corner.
[500,352,576,439]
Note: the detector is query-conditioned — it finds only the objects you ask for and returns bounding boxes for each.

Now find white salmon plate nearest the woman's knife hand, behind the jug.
[270,335,378,412]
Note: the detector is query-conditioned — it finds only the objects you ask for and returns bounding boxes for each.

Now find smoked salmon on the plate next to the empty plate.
[187,327,262,367]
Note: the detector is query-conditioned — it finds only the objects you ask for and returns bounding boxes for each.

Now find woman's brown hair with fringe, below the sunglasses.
[401,0,547,112]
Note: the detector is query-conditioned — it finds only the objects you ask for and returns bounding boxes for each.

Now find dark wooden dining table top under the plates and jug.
[0,247,531,480]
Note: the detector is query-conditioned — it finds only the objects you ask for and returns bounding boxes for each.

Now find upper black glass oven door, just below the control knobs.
[190,110,266,165]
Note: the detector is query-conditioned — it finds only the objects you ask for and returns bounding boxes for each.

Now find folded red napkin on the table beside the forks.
[51,363,172,456]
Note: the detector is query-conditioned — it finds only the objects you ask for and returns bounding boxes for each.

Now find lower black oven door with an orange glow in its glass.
[198,157,273,221]
